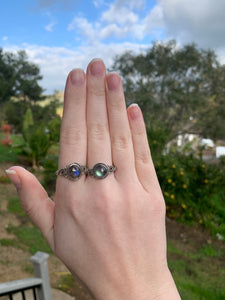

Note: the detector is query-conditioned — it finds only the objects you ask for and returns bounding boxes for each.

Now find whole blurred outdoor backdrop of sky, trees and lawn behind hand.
[0,0,225,300]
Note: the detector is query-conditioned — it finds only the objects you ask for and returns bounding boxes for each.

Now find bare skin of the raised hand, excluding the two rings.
[7,59,180,300]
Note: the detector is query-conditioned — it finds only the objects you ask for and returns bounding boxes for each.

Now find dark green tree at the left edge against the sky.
[0,48,43,103]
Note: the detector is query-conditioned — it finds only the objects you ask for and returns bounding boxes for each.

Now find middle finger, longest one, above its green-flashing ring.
[87,59,112,168]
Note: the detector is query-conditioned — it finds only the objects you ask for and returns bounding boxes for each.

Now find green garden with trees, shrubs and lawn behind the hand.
[0,41,225,300]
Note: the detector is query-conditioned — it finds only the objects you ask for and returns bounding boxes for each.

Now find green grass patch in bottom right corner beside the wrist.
[168,242,225,300]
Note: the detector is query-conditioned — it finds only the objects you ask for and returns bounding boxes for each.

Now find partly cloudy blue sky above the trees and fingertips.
[0,0,225,94]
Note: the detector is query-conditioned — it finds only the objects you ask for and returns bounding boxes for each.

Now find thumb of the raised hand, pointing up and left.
[6,167,55,249]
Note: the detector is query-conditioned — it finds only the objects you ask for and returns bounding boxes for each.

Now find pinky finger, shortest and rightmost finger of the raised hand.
[127,104,158,192]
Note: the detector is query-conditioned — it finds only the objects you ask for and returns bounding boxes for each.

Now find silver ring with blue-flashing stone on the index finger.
[56,163,87,181]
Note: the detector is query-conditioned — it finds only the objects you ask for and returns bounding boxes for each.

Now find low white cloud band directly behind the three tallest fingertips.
[4,42,147,94]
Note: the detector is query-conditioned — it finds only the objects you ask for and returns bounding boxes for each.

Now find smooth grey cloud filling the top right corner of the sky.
[158,0,225,48]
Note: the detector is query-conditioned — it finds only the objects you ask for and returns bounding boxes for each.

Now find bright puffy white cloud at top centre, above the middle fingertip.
[68,0,156,44]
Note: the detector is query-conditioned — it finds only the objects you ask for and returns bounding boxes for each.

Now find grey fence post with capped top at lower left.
[30,251,52,300]
